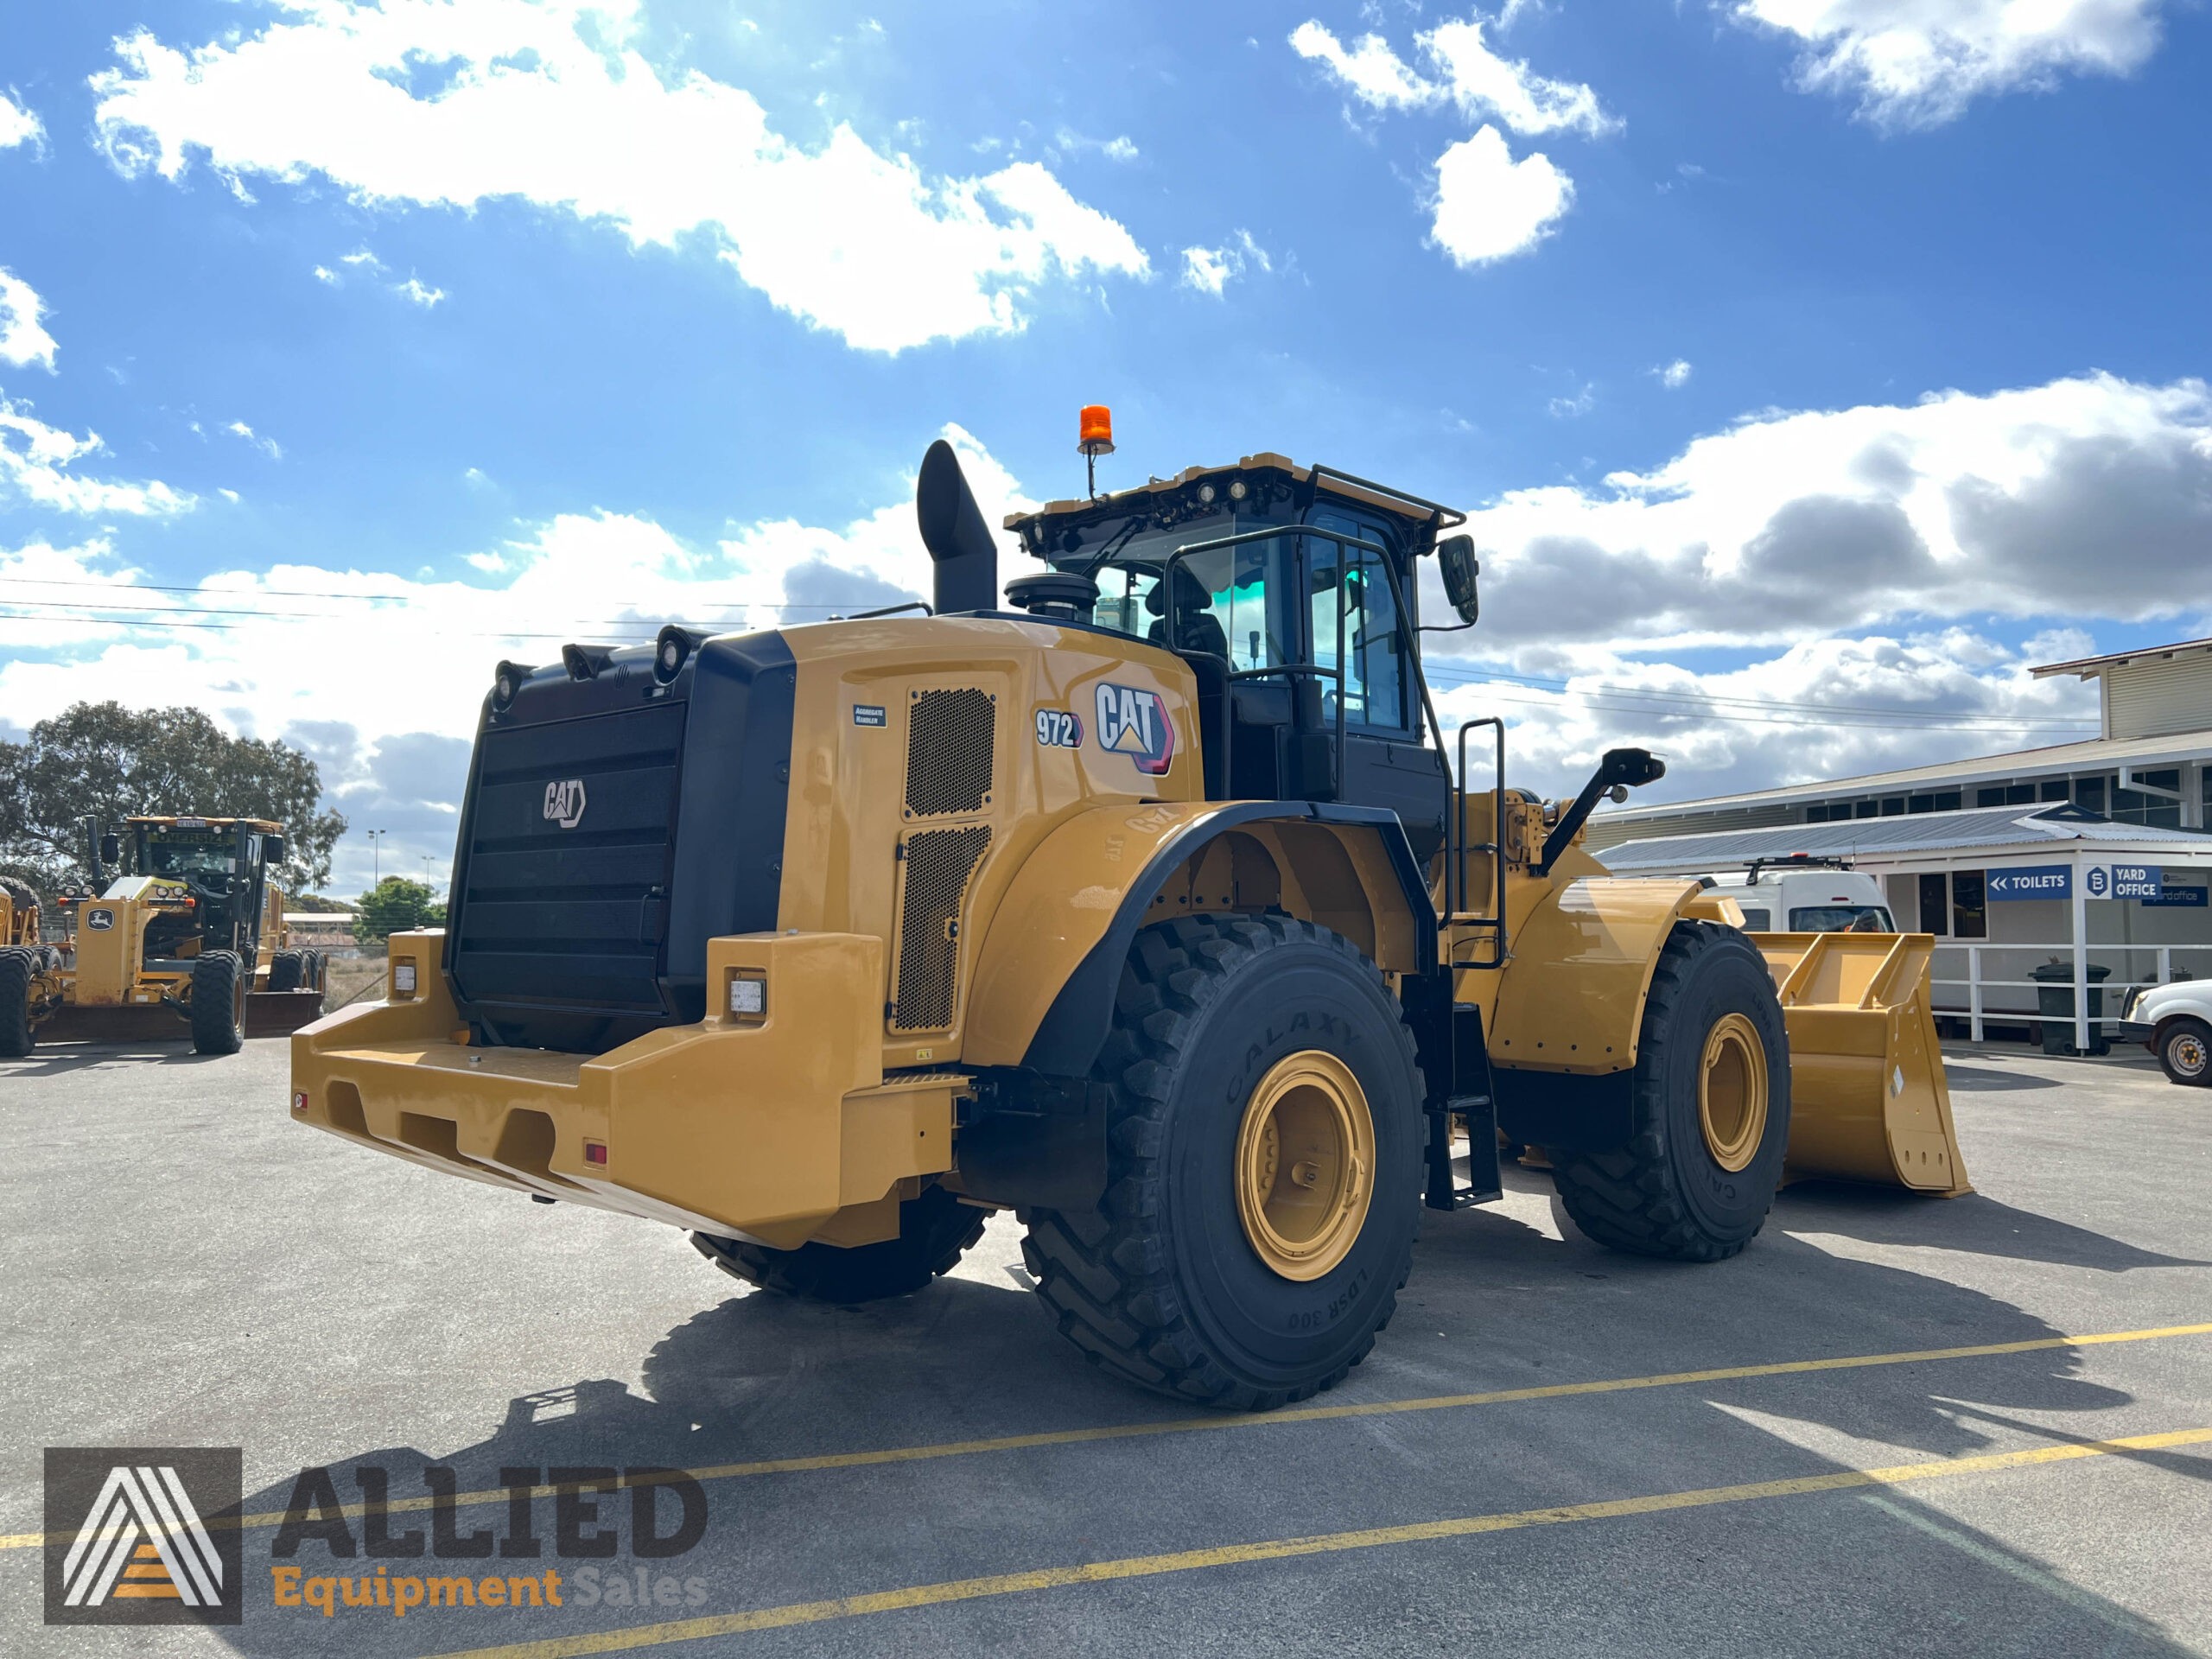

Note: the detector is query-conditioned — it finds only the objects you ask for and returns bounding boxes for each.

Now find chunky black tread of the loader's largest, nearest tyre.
[1022,913,1421,1411]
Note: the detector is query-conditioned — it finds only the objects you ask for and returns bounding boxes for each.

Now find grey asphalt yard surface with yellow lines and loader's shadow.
[0,1039,2212,1659]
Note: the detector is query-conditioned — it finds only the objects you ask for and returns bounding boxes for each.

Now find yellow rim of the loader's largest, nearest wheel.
[1236,1048,1376,1281]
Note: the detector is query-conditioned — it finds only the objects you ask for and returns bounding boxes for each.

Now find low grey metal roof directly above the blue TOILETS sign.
[1592,803,2212,876]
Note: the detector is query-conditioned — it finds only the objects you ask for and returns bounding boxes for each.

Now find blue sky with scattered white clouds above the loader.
[0,0,2212,889]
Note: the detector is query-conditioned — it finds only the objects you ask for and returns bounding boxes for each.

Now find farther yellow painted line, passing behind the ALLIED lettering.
[0,1323,2212,1551]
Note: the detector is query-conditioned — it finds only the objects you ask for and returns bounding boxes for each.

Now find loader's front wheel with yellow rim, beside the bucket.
[1546,923,1789,1261]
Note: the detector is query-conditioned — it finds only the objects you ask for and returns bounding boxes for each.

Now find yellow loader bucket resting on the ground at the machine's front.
[1752,933,1974,1199]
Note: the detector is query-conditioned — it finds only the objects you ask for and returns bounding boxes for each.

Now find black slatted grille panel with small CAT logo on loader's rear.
[451,702,686,1013]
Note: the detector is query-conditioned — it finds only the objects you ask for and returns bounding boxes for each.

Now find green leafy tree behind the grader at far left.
[0,703,345,892]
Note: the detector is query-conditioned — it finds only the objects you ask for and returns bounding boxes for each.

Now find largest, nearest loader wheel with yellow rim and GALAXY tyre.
[1022,916,1422,1411]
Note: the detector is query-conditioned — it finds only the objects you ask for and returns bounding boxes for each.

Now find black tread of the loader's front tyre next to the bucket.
[1551,923,1787,1261]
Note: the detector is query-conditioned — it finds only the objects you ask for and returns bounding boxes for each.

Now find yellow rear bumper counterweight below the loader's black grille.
[292,933,963,1249]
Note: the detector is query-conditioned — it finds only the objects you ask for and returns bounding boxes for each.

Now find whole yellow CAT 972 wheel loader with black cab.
[292,422,1964,1409]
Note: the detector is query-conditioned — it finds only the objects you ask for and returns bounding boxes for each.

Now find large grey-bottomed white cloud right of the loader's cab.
[1442,374,2212,651]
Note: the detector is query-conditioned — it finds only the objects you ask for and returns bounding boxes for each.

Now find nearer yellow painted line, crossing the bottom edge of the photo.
[427,1429,2212,1659]
